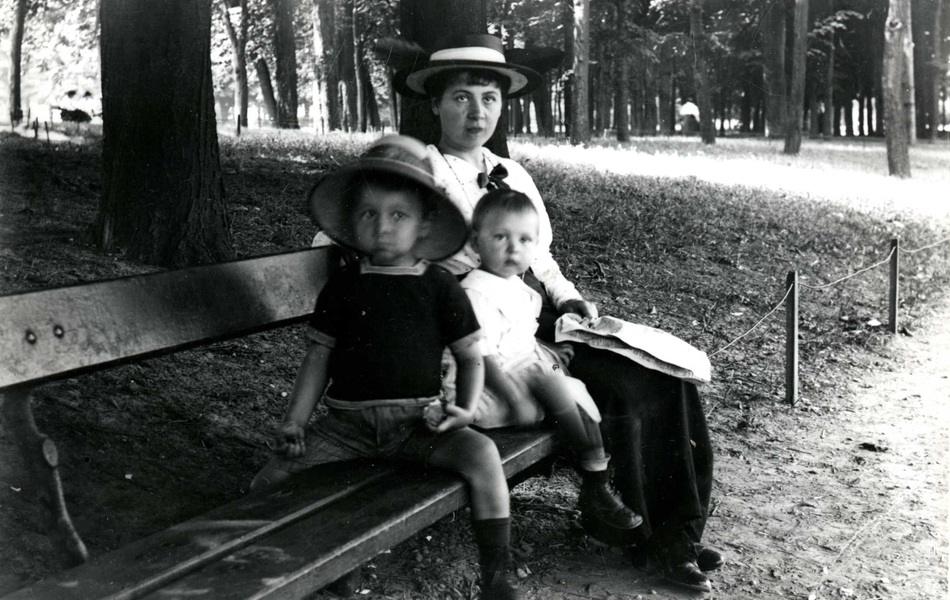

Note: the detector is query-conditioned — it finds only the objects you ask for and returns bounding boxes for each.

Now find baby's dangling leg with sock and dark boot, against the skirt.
[527,376,643,542]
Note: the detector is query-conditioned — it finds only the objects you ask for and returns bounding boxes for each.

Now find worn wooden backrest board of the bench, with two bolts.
[0,249,328,390]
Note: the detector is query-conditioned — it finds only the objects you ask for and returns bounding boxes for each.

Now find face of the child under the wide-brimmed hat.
[352,183,429,267]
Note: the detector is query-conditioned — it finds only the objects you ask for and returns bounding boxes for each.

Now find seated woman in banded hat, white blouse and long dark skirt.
[394,35,722,592]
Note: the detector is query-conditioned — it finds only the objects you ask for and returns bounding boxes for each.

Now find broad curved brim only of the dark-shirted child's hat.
[308,158,468,261]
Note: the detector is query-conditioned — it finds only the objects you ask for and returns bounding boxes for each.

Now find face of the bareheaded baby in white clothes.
[473,210,538,278]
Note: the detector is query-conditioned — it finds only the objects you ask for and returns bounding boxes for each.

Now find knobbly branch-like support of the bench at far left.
[0,389,89,566]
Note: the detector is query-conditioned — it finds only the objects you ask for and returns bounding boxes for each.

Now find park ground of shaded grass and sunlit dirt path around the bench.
[0,133,950,600]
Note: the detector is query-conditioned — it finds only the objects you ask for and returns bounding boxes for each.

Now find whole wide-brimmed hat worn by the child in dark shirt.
[309,135,468,260]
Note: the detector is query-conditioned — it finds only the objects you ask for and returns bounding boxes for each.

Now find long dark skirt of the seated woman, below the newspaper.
[536,282,713,546]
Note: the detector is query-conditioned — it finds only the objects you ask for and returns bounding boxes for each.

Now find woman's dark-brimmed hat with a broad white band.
[393,34,541,98]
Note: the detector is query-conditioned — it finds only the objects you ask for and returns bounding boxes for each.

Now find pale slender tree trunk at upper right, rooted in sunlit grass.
[881,0,910,178]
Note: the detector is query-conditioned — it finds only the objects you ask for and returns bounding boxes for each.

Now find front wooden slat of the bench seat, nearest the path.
[145,431,555,600]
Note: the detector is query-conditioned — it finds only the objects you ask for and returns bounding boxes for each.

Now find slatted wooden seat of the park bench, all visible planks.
[4,430,555,600]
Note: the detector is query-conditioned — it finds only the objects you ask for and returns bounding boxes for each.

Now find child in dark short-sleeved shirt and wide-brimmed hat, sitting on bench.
[251,136,517,599]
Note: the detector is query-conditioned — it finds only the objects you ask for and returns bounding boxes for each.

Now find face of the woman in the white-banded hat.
[432,78,502,152]
